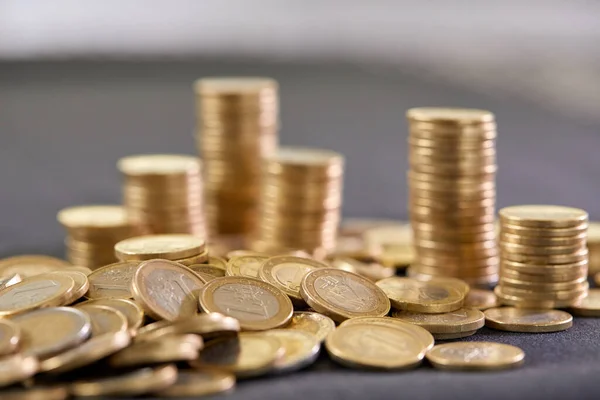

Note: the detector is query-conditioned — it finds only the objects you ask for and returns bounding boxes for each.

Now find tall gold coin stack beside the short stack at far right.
[407,108,498,286]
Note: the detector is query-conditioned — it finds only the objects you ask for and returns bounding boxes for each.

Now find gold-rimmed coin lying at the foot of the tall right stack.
[376,277,465,313]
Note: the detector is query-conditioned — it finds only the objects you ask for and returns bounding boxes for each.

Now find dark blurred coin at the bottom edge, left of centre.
[155,369,235,397]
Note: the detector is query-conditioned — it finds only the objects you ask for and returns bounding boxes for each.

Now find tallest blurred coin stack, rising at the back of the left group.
[194,78,279,235]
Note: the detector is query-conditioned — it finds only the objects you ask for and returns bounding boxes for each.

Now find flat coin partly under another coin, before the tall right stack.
[392,308,485,333]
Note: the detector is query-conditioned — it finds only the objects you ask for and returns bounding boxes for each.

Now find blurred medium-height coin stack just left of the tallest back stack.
[117,154,206,238]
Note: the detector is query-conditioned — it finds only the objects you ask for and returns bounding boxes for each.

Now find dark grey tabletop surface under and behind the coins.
[0,61,600,400]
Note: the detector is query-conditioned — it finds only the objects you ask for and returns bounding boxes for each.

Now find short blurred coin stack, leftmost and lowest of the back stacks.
[57,205,140,269]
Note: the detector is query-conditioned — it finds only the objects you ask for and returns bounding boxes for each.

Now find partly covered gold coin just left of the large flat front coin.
[264,329,321,373]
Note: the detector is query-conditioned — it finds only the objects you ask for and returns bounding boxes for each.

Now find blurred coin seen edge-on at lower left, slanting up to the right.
[40,330,131,374]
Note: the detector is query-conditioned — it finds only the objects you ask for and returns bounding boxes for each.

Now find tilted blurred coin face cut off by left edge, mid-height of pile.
[0,274,75,316]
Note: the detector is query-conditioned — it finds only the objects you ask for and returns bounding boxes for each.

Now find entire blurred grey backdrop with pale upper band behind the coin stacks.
[0,0,600,254]
